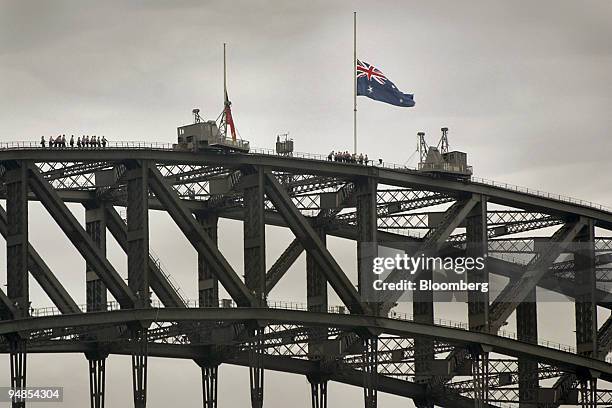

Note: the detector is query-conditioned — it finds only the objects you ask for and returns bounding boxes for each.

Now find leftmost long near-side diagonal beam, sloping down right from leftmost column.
[29,165,136,308]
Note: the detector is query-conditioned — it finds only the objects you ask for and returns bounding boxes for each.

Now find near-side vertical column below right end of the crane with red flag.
[241,168,266,408]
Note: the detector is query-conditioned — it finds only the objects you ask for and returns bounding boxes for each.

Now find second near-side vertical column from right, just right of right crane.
[466,196,489,332]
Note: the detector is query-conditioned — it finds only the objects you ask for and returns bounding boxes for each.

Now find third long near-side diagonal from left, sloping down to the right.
[266,173,365,313]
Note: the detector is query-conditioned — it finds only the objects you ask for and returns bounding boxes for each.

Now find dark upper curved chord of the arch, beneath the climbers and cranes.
[0,148,612,229]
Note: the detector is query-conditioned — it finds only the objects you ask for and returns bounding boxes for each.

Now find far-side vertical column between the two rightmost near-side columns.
[516,289,540,408]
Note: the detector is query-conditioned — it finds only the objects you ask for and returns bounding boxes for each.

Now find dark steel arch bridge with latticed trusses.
[0,143,612,408]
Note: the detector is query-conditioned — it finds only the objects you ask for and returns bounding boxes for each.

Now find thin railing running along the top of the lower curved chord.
[30,299,592,362]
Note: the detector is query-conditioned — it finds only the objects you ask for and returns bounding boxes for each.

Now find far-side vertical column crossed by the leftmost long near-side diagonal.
[85,202,107,312]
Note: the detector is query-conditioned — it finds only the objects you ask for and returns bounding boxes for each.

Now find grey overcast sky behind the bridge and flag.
[0,0,612,408]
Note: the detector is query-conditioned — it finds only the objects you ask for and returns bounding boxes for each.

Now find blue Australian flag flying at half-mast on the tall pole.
[356,60,414,107]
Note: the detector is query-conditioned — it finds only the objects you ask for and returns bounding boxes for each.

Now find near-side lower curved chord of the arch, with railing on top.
[5,308,612,381]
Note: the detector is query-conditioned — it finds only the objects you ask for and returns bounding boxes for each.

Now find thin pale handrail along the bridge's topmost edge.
[0,140,612,212]
